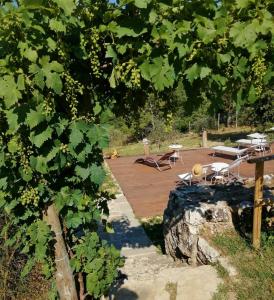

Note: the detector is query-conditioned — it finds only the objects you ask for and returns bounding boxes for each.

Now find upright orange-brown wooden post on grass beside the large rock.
[252,161,264,249]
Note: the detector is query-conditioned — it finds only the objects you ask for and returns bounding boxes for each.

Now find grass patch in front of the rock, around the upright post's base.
[213,232,274,300]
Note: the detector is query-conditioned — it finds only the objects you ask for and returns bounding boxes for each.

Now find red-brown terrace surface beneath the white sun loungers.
[107,149,274,217]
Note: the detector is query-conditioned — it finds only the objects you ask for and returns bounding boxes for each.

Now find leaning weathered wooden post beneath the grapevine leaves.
[44,204,78,300]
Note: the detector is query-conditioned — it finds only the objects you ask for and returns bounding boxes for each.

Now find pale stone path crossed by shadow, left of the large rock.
[104,194,221,300]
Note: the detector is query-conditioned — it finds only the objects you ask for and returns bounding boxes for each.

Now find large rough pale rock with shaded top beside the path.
[164,185,252,265]
